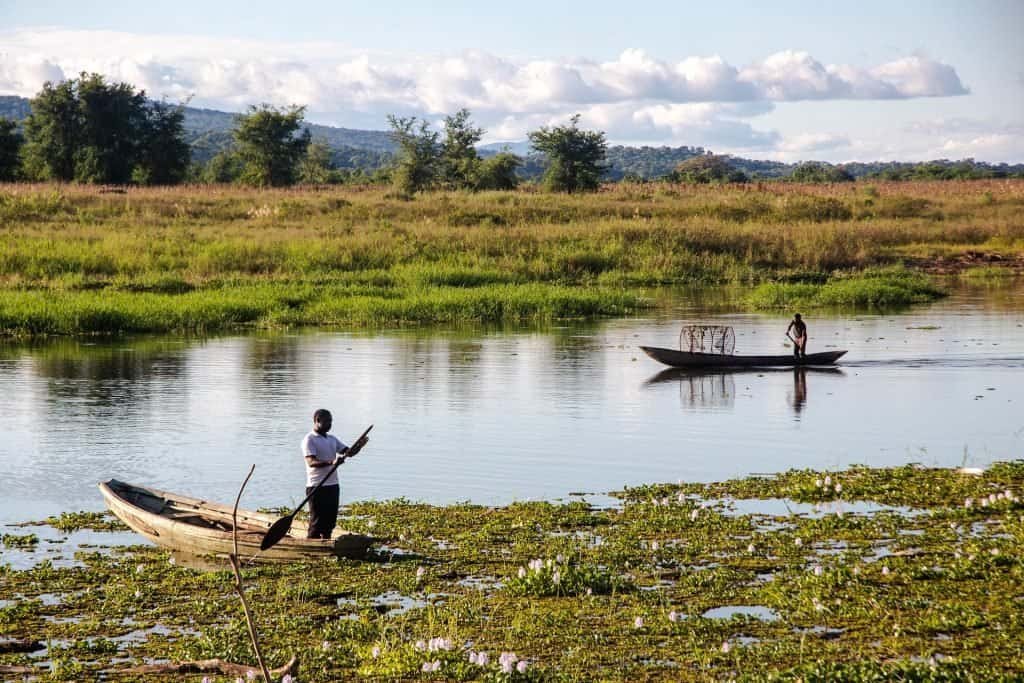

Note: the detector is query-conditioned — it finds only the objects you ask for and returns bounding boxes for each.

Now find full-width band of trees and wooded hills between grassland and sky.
[0,73,1024,189]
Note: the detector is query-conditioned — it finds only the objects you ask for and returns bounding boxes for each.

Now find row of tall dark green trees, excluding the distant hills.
[0,73,607,196]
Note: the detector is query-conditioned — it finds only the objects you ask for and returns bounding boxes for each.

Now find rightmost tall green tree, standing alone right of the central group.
[528,114,608,193]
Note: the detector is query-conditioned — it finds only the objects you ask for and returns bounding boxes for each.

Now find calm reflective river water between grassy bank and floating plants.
[0,283,1024,523]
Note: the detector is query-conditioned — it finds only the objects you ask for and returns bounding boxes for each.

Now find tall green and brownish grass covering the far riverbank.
[0,179,1024,337]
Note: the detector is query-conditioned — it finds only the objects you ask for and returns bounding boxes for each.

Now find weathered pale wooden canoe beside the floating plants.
[99,479,374,561]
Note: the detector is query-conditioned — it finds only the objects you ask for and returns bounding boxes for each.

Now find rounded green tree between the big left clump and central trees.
[234,104,310,186]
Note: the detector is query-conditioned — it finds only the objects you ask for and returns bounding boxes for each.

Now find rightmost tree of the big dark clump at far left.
[133,101,191,185]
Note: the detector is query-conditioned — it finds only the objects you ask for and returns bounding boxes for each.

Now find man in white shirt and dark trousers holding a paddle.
[302,408,362,539]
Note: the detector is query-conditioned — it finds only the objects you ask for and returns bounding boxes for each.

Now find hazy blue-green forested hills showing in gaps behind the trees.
[0,95,1024,180]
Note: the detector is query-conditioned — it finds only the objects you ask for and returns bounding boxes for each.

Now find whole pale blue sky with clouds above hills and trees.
[0,0,1024,163]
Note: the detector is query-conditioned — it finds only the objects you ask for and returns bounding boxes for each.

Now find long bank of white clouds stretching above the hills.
[0,29,991,157]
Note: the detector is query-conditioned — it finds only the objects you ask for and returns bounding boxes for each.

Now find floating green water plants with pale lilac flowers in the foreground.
[0,460,1024,682]
